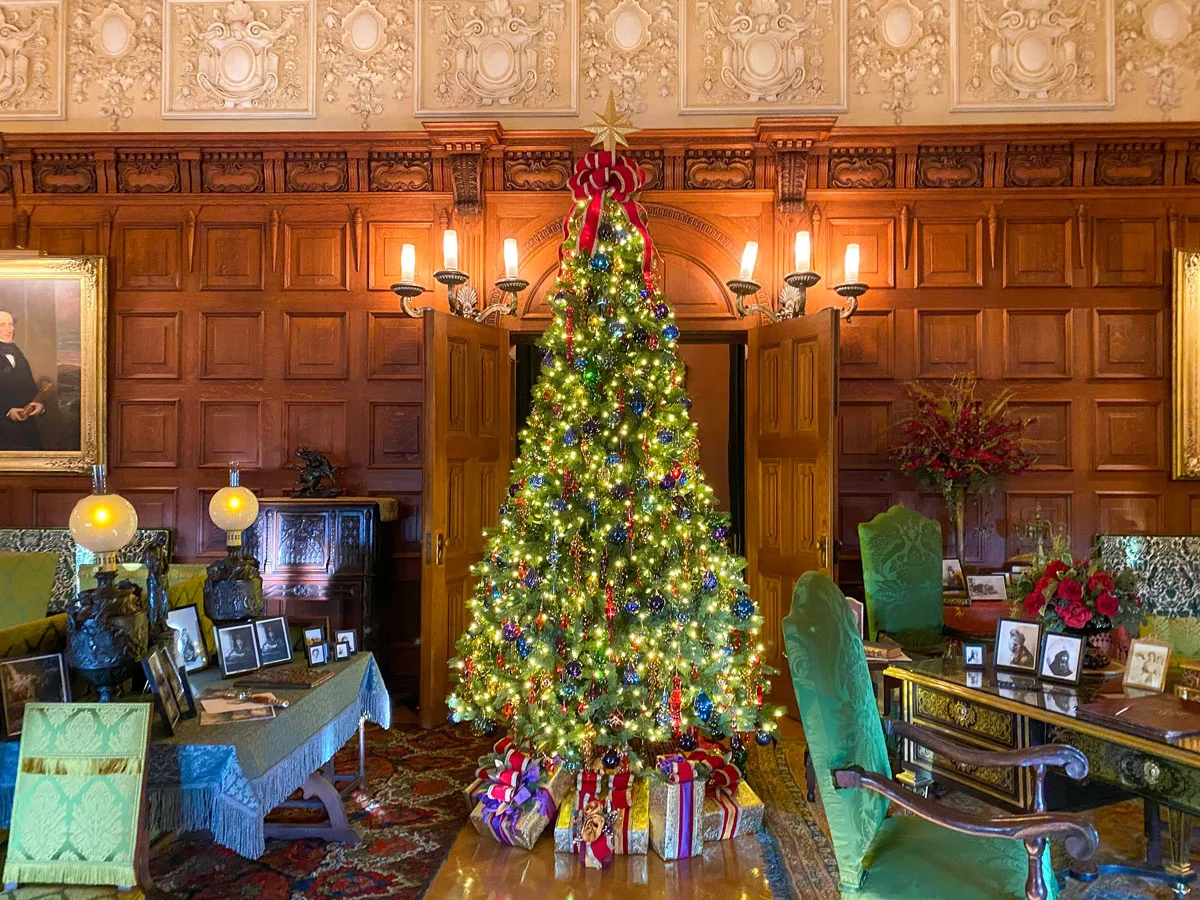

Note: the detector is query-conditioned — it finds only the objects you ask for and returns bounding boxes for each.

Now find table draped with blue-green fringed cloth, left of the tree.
[0,653,391,859]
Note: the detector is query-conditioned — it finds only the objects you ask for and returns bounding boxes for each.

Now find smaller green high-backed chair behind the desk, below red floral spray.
[858,504,946,653]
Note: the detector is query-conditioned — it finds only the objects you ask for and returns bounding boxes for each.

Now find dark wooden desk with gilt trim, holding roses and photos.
[884,659,1200,884]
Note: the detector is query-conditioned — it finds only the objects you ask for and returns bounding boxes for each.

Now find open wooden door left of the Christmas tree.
[420,311,512,728]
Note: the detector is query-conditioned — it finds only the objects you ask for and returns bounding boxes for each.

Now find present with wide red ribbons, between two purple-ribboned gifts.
[554,772,650,869]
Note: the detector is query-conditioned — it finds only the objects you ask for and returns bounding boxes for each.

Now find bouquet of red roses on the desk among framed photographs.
[1013,553,1146,635]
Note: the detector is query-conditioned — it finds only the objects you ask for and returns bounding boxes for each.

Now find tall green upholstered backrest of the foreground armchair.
[784,572,892,889]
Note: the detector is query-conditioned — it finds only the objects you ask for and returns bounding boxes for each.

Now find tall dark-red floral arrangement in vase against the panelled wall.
[893,376,1037,554]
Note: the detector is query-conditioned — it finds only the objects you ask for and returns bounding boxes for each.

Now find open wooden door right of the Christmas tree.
[745,308,840,716]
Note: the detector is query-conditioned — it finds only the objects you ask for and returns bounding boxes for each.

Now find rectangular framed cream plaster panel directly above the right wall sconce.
[682,0,847,113]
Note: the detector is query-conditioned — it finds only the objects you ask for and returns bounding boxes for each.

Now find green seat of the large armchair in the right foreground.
[844,816,1058,900]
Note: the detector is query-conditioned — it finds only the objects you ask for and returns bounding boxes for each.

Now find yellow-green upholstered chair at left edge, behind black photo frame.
[0,553,67,659]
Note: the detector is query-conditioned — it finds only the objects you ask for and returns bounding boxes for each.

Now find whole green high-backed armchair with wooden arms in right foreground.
[784,572,1097,900]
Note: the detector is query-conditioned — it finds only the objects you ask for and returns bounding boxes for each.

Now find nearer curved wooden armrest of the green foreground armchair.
[833,766,1099,859]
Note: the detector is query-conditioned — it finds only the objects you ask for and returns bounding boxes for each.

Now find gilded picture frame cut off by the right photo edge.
[1171,250,1200,479]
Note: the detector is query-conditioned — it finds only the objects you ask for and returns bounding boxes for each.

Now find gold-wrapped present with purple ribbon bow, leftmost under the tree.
[470,745,570,850]
